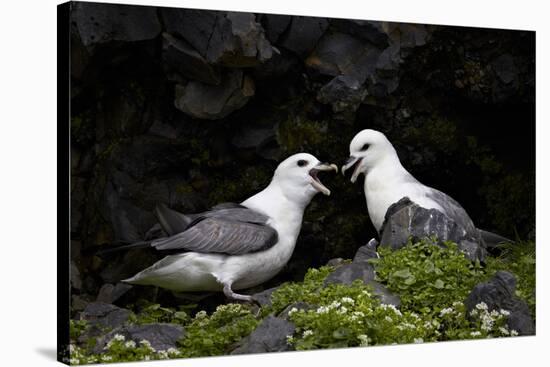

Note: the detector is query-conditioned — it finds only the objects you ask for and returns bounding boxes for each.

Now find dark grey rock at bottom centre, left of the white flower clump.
[231,316,295,354]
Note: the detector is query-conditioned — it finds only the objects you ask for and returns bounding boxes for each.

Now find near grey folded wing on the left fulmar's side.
[151,217,278,255]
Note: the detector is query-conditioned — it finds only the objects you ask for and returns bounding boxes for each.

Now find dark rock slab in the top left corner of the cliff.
[72,2,161,47]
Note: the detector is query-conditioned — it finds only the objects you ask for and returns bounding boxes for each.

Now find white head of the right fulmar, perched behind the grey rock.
[342,129,397,182]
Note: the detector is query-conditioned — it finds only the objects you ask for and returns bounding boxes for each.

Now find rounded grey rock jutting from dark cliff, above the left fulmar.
[175,70,254,120]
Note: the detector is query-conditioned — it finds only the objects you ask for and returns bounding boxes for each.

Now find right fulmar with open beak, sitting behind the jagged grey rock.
[342,129,509,256]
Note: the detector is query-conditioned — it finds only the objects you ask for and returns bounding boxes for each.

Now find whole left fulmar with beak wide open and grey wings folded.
[118,153,338,301]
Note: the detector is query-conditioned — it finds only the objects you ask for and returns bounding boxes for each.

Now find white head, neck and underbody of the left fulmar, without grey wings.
[125,153,336,300]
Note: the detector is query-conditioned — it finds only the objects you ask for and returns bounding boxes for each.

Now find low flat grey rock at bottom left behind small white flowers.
[94,324,185,353]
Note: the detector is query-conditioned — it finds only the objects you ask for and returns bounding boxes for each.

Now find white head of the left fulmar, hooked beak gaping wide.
[273,153,338,197]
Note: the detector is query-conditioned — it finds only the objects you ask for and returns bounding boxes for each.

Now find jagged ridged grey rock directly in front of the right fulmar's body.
[380,197,486,261]
